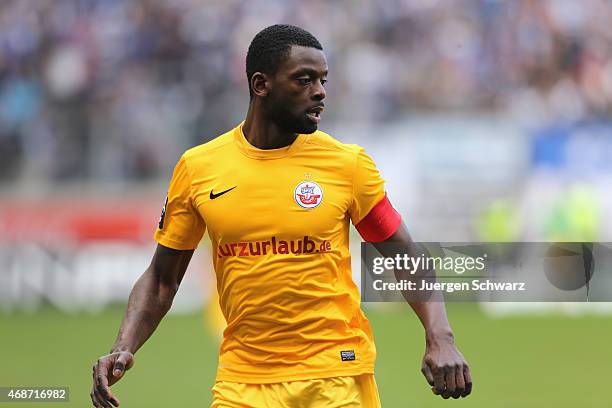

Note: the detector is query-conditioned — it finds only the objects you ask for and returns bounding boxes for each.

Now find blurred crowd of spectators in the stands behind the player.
[0,0,612,185]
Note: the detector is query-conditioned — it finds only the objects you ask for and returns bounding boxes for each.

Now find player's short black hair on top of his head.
[246,24,323,97]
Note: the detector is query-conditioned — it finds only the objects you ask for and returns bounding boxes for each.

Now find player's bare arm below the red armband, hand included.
[375,223,472,399]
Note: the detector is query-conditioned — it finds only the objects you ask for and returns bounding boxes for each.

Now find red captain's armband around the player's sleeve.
[355,194,402,242]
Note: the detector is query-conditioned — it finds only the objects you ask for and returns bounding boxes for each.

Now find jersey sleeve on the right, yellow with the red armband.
[349,148,402,242]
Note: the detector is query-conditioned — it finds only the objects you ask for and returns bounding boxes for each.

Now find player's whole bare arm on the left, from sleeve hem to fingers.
[91,245,193,408]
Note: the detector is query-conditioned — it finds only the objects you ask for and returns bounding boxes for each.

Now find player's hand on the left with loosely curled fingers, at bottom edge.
[90,351,134,408]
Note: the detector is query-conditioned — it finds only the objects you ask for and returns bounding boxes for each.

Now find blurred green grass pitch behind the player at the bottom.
[0,304,612,408]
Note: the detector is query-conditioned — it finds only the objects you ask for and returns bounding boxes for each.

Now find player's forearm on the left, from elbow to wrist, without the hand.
[111,269,176,353]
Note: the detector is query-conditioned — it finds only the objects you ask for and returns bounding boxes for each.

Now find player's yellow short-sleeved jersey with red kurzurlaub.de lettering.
[155,125,399,383]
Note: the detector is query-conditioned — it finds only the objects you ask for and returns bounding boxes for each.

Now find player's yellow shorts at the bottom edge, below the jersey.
[211,374,380,408]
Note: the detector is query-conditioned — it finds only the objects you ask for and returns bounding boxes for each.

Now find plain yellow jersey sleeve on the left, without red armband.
[154,156,206,250]
